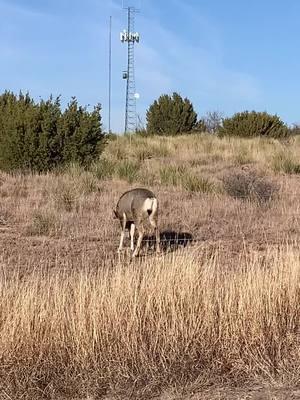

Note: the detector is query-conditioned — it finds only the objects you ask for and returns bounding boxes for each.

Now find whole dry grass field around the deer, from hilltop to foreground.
[0,135,300,400]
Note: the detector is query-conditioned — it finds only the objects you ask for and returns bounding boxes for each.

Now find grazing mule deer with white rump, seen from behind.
[114,188,160,257]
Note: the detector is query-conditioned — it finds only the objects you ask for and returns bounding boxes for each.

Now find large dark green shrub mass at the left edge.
[0,92,105,172]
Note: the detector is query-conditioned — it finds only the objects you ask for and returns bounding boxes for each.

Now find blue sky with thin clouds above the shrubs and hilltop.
[0,0,300,132]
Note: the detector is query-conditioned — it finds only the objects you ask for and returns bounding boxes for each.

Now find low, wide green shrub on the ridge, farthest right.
[218,111,290,138]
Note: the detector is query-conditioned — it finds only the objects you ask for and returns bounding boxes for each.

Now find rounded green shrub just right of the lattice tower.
[146,93,197,135]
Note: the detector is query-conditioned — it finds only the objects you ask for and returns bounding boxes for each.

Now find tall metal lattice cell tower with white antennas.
[120,7,140,133]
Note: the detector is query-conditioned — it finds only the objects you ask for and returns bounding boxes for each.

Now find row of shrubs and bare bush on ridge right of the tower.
[146,93,300,138]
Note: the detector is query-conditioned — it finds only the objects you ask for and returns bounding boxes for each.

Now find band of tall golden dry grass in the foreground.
[0,247,300,398]
